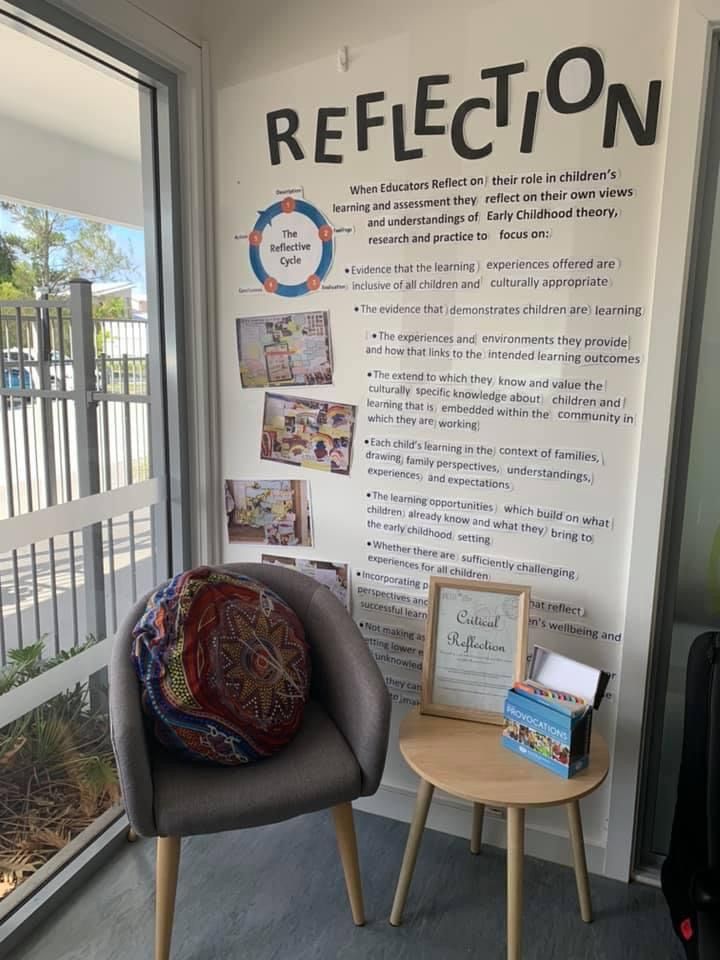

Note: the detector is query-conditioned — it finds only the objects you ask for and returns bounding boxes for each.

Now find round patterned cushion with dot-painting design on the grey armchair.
[132,567,310,765]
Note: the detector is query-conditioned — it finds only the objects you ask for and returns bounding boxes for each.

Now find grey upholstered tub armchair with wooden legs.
[110,563,390,960]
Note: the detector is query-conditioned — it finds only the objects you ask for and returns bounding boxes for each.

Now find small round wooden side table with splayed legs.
[390,710,609,960]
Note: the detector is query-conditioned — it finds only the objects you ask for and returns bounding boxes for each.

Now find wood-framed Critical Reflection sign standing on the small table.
[420,577,530,724]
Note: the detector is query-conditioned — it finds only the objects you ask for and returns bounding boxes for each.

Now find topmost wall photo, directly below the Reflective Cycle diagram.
[236,311,333,387]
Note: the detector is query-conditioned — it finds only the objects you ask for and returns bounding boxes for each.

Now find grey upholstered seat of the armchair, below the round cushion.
[151,700,361,836]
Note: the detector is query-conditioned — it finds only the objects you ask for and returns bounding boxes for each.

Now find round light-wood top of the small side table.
[400,709,610,807]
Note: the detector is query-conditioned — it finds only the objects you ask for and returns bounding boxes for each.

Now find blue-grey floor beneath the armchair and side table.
[13,814,680,960]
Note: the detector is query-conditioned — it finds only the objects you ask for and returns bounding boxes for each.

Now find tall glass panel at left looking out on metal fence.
[0,3,187,928]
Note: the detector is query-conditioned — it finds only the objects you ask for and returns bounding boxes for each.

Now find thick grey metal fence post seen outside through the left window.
[70,280,107,640]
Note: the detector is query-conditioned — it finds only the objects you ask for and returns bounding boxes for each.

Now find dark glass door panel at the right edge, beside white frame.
[638,40,720,868]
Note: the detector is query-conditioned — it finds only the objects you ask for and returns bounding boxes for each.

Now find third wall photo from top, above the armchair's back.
[225,480,313,547]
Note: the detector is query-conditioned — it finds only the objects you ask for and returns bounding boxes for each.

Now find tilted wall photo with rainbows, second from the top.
[260,393,356,476]
